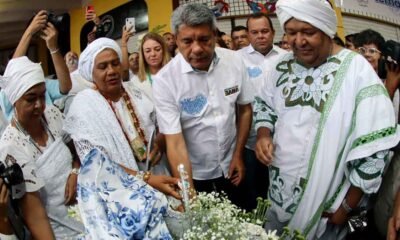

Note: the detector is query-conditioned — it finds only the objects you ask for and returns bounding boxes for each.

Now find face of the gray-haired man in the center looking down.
[176,24,216,71]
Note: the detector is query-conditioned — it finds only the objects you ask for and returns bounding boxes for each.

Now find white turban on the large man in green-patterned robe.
[276,0,336,38]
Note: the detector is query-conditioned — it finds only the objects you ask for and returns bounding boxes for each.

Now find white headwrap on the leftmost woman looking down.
[0,56,45,105]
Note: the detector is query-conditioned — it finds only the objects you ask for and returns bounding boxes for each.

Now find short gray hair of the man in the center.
[171,3,217,34]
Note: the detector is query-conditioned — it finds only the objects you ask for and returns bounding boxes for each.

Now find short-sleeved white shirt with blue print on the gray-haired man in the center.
[153,48,254,180]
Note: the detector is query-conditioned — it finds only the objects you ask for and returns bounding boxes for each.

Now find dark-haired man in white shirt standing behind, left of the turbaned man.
[238,13,287,210]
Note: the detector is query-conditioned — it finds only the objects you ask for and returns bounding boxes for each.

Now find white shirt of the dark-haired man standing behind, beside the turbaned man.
[238,44,287,150]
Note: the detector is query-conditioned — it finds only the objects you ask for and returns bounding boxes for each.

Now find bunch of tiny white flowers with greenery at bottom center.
[166,192,305,240]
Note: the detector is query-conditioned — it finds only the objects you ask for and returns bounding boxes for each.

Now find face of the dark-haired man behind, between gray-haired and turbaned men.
[248,17,275,55]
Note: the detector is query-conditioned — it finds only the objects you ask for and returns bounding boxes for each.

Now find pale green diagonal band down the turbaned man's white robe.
[299,52,357,236]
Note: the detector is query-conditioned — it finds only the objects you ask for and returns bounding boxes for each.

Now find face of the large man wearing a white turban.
[285,18,332,67]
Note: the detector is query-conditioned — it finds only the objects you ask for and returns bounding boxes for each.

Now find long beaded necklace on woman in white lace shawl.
[107,87,148,159]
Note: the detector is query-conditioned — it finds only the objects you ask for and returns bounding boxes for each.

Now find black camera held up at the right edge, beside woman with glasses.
[378,40,400,79]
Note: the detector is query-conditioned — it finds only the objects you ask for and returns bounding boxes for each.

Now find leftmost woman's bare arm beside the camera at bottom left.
[19,192,55,240]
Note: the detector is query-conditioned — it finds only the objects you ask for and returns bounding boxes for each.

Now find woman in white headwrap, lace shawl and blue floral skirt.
[64,38,179,239]
